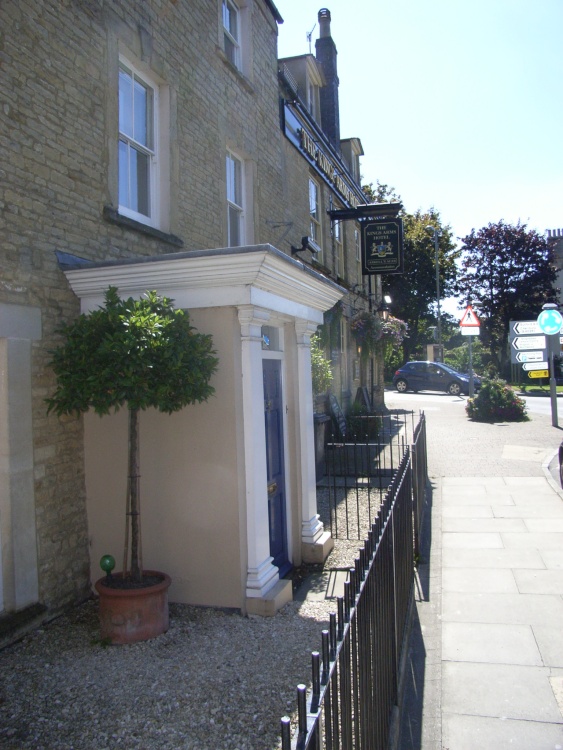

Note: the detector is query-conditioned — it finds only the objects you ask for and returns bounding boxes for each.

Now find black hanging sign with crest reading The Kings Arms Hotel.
[362,219,403,275]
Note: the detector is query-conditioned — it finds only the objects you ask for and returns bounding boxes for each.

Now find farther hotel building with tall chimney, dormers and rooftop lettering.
[279,8,383,412]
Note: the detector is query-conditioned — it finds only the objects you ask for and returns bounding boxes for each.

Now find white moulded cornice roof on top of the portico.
[60,244,345,323]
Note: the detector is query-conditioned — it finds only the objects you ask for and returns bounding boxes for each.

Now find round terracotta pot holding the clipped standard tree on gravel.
[94,570,171,644]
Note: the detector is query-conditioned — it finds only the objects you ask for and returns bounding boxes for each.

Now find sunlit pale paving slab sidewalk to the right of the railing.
[386,394,563,750]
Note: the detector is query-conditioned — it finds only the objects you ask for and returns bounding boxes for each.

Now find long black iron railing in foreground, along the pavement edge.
[281,447,414,750]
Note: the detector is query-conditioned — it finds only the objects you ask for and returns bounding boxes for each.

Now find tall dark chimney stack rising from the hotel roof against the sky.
[315,8,340,153]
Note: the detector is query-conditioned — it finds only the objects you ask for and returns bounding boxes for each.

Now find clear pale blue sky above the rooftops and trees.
[275,0,563,244]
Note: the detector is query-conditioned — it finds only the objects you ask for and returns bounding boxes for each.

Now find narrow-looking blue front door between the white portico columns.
[262,359,291,577]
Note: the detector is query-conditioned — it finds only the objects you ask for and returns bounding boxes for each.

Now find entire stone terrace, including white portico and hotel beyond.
[0,0,386,640]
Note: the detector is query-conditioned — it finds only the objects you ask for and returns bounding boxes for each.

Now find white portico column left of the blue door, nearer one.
[238,305,279,598]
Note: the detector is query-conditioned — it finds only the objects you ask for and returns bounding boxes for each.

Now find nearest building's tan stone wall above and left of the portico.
[0,0,284,613]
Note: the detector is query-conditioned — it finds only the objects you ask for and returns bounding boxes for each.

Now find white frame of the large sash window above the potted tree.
[118,55,161,227]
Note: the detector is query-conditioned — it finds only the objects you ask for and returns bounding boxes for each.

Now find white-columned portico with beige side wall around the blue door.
[63,245,344,614]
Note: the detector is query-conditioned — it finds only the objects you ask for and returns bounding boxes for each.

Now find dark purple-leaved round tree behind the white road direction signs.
[456,221,558,377]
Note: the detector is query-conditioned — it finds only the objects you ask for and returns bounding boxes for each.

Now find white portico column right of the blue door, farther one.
[295,320,334,562]
